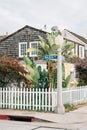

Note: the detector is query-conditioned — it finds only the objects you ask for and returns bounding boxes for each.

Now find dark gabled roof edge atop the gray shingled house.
[0,25,49,42]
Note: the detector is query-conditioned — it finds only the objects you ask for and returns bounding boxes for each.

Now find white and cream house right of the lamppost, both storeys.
[63,29,87,86]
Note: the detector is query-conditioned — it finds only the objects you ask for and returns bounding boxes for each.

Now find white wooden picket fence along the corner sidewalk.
[0,86,87,111]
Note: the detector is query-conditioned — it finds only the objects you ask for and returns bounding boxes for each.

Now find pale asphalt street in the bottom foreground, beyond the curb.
[0,120,71,130]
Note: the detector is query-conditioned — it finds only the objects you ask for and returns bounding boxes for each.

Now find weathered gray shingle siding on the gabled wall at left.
[0,26,47,58]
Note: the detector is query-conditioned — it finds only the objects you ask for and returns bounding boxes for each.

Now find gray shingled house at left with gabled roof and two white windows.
[0,25,47,59]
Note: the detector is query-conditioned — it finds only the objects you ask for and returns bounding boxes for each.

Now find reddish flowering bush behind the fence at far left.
[0,56,30,87]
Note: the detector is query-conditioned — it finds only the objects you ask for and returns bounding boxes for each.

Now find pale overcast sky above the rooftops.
[0,0,87,38]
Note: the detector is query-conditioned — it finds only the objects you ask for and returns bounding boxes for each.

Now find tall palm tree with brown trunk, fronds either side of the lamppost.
[26,30,74,88]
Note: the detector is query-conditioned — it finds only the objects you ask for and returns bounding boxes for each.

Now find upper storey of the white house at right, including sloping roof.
[63,29,87,59]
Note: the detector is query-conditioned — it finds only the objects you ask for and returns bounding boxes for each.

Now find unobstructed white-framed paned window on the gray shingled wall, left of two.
[19,42,27,57]
